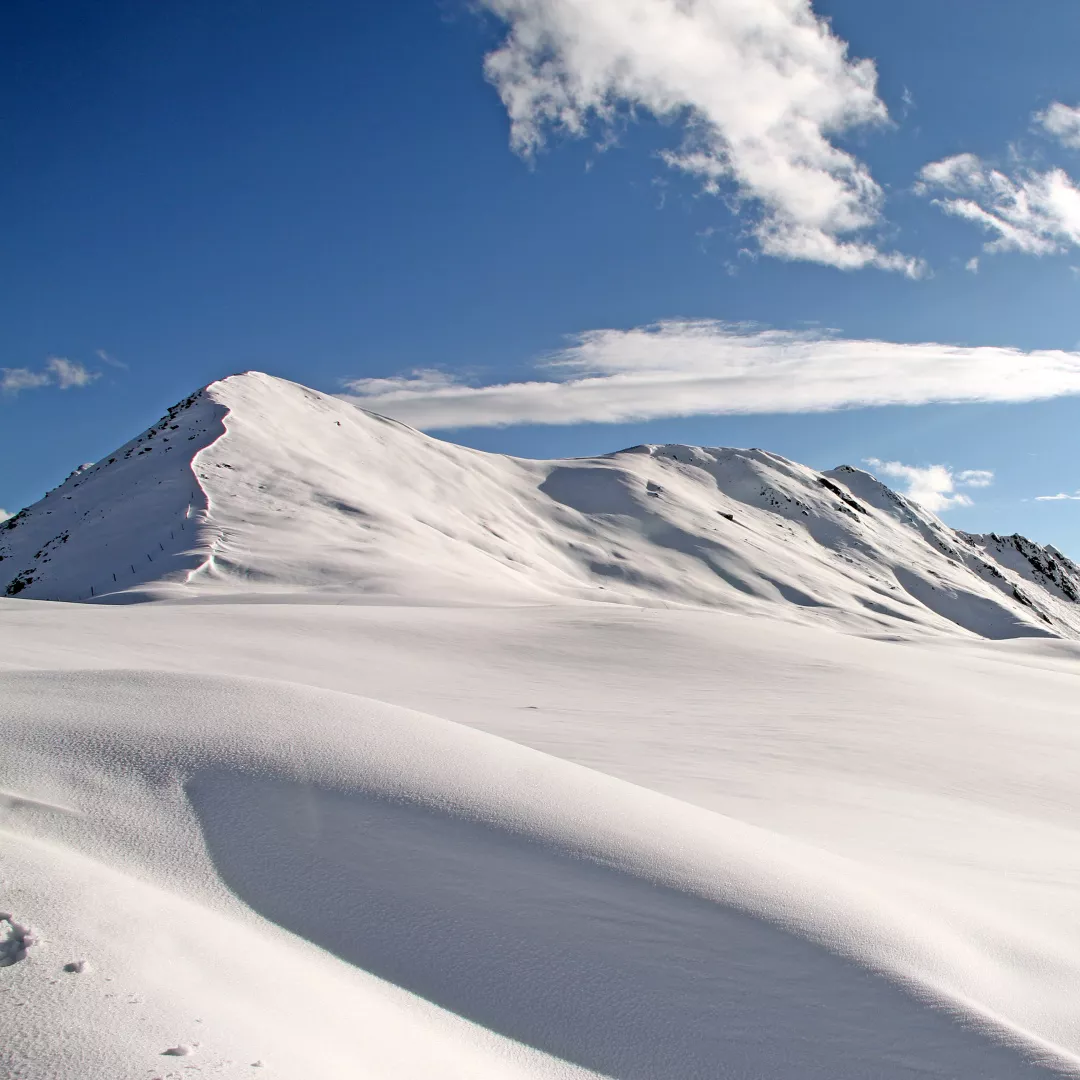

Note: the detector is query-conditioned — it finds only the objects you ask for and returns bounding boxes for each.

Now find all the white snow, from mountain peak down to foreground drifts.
[0,375,1080,1080]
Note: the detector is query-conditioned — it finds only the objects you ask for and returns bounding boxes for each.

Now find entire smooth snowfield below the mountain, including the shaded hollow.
[0,599,1080,1080]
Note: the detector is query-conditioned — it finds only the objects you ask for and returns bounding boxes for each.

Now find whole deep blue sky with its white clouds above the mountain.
[6,0,1080,556]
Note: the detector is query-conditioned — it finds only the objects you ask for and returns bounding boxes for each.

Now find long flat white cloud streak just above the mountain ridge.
[343,320,1080,429]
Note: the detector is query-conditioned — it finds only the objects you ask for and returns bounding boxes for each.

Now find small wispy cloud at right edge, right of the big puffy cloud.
[916,153,1080,255]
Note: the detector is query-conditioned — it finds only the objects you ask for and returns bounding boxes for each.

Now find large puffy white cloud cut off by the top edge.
[477,0,922,276]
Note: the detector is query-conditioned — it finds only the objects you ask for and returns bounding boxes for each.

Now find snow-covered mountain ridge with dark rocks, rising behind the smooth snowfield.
[0,372,1080,638]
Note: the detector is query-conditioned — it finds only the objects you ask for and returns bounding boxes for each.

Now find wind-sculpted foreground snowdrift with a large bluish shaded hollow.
[0,648,1080,1080]
